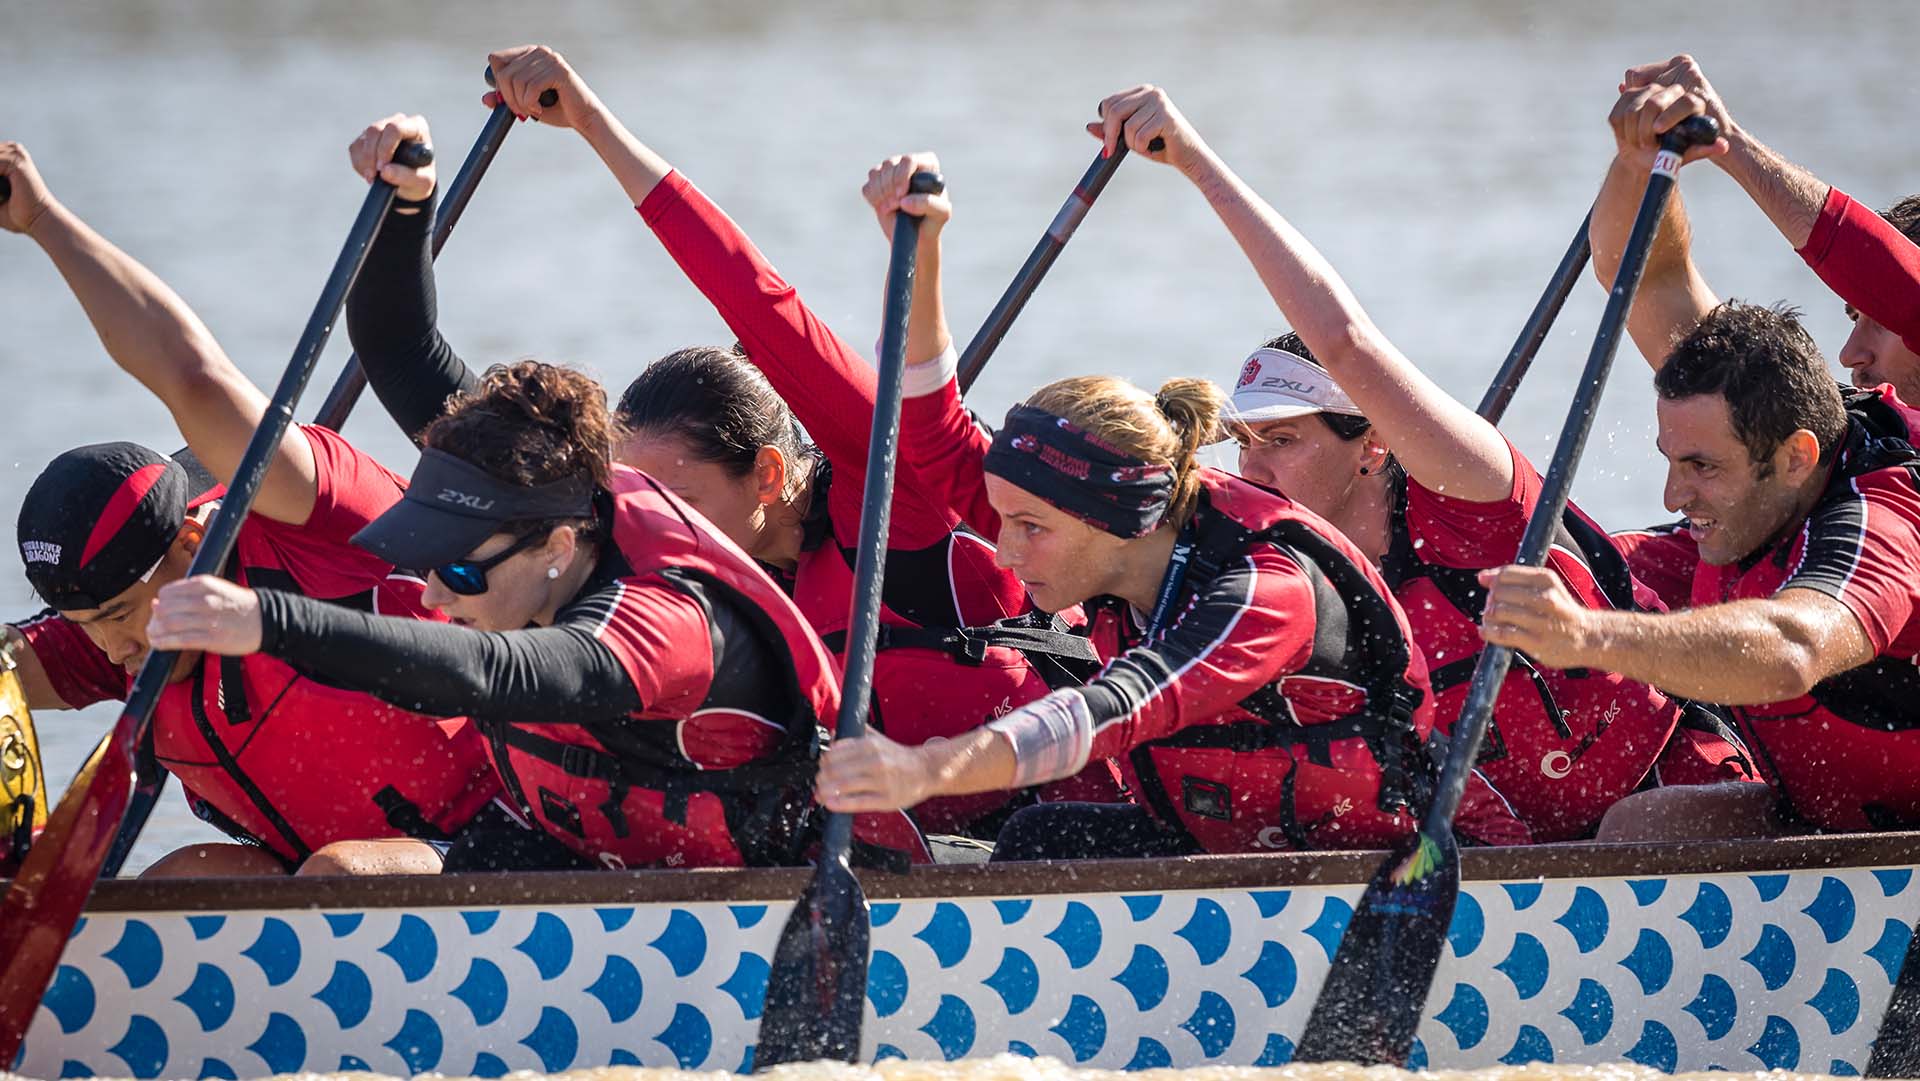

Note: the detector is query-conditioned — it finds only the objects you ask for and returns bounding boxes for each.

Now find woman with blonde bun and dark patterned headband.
[818,359,1524,860]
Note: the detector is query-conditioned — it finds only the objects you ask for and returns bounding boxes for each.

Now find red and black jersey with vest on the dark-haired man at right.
[1693,386,1920,829]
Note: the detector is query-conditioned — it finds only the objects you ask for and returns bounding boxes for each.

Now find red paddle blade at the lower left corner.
[0,714,134,1069]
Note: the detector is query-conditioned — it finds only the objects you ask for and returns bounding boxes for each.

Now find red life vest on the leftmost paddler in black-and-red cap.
[154,565,499,864]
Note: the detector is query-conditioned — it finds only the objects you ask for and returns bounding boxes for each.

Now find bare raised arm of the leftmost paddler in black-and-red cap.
[0,142,317,526]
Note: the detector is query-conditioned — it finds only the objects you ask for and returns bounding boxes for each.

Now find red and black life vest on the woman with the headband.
[1094,468,1438,853]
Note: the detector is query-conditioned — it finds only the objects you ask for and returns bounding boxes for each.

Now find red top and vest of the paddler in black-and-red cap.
[21,426,499,862]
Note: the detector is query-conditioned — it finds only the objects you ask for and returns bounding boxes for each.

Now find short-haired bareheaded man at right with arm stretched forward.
[1482,301,1920,839]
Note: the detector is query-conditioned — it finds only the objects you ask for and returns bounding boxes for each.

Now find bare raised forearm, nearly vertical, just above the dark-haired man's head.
[1588,156,1720,371]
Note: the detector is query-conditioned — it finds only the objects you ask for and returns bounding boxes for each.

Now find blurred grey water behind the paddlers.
[0,0,1920,870]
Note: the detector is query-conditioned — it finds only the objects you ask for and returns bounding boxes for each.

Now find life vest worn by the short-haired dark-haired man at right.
[1720,388,1920,831]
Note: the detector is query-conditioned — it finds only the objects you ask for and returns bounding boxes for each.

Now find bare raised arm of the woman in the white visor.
[1087,86,1513,501]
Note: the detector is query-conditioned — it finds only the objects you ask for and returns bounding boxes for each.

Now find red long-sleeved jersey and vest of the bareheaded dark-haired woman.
[637,173,1119,831]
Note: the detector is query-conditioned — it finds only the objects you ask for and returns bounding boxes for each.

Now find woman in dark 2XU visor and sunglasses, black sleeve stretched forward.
[150,361,925,870]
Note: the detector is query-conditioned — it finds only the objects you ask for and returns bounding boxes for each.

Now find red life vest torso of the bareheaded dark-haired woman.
[793,461,1119,837]
